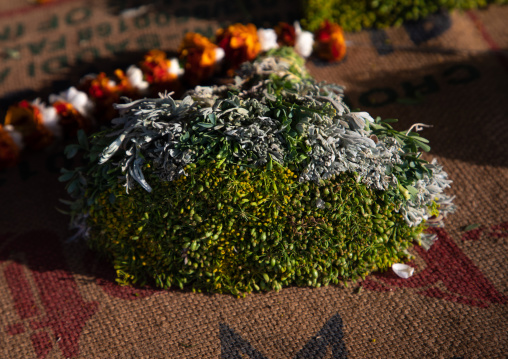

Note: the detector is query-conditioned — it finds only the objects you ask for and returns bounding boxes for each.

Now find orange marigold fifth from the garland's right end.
[140,50,179,84]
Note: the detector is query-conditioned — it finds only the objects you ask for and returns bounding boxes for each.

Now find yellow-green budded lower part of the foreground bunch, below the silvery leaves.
[88,162,423,295]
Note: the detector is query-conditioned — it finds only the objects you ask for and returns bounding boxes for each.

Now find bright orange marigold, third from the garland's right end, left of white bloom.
[216,24,261,70]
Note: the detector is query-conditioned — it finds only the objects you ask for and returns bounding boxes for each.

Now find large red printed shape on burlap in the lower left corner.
[0,231,99,358]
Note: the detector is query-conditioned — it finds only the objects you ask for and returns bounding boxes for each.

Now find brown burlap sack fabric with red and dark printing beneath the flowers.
[0,0,508,359]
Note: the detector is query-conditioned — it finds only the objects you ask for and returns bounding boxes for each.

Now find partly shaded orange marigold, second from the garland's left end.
[5,100,53,149]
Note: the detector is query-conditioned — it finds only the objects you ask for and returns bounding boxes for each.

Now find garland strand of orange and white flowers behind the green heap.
[0,21,346,169]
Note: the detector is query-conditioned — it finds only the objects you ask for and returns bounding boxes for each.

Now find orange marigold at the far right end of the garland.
[315,20,346,62]
